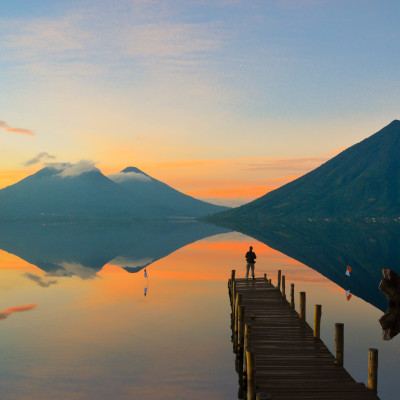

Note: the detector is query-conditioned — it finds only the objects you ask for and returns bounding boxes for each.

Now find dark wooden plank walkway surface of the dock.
[229,278,379,400]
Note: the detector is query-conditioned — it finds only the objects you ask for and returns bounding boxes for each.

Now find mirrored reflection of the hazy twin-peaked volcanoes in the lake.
[0,221,229,280]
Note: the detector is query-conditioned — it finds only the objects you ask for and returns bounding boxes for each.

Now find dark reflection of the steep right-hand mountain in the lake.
[214,221,400,311]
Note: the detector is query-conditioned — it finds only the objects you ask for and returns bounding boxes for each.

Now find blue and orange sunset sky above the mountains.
[0,0,400,205]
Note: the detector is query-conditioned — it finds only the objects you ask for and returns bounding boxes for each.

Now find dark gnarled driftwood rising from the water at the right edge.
[379,268,400,340]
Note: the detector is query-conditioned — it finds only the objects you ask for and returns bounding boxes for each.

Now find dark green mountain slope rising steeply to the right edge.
[209,120,400,220]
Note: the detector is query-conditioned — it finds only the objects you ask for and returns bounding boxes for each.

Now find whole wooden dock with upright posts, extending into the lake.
[228,271,379,400]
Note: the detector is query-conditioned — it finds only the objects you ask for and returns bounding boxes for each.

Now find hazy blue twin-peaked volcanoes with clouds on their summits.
[0,162,227,219]
